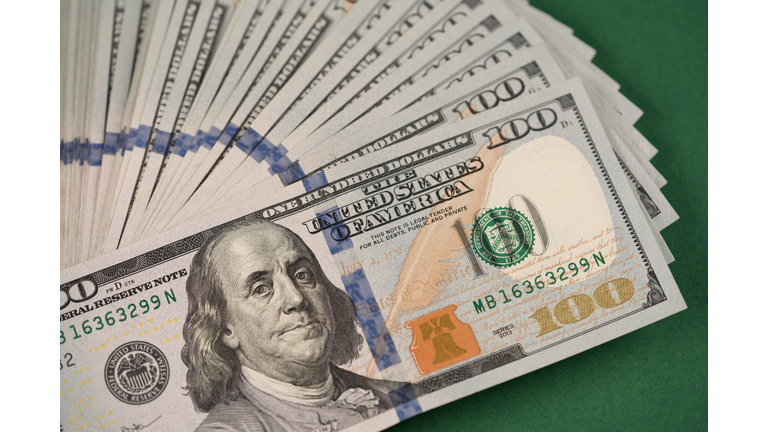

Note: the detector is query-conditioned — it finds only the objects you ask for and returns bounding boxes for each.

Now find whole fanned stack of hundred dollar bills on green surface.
[60,0,685,431]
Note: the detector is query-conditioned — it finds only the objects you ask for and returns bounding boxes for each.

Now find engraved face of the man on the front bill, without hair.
[213,225,335,376]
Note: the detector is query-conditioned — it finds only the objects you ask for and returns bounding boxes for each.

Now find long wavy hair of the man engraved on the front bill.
[181,221,363,412]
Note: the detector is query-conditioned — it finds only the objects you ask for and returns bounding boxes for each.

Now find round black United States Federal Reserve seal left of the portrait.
[104,341,168,405]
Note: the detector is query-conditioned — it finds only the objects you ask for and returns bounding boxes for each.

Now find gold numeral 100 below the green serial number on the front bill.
[529,278,635,337]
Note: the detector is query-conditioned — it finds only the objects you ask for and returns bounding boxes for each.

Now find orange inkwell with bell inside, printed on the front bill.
[405,305,480,375]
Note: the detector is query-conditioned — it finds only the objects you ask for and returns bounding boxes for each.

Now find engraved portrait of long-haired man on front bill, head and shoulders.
[181,221,416,431]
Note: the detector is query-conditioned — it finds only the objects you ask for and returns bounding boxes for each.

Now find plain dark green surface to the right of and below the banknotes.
[391,0,707,432]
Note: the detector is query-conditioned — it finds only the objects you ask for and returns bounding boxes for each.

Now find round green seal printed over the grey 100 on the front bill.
[472,207,535,268]
